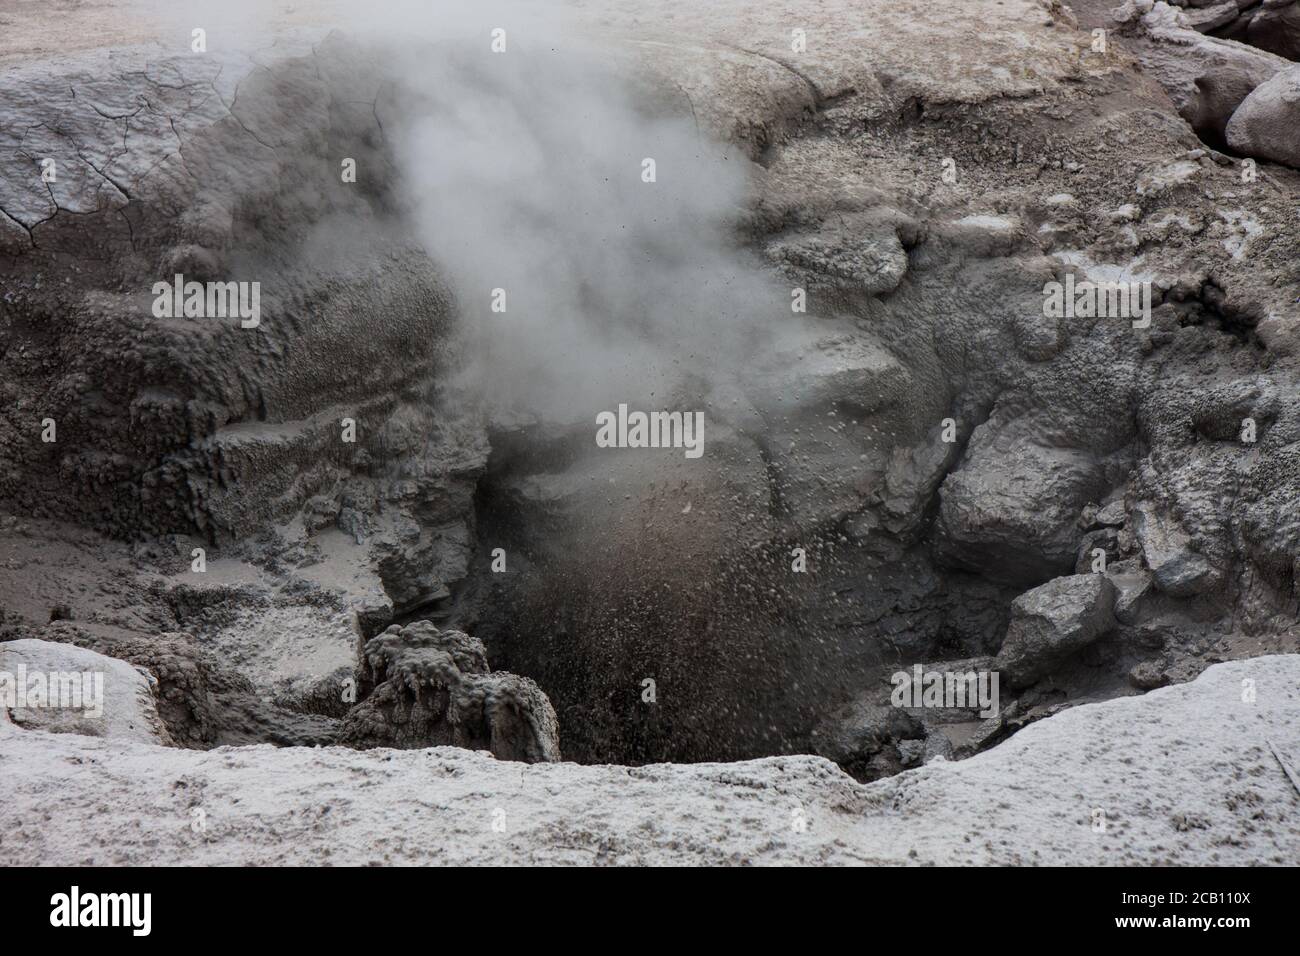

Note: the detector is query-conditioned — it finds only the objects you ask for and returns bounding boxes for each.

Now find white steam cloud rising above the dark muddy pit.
[371,4,788,420]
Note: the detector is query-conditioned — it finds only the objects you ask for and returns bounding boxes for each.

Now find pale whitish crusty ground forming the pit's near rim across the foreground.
[0,656,1300,865]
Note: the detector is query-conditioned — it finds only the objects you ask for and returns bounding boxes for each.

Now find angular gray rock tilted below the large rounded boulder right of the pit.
[997,574,1115,687]
